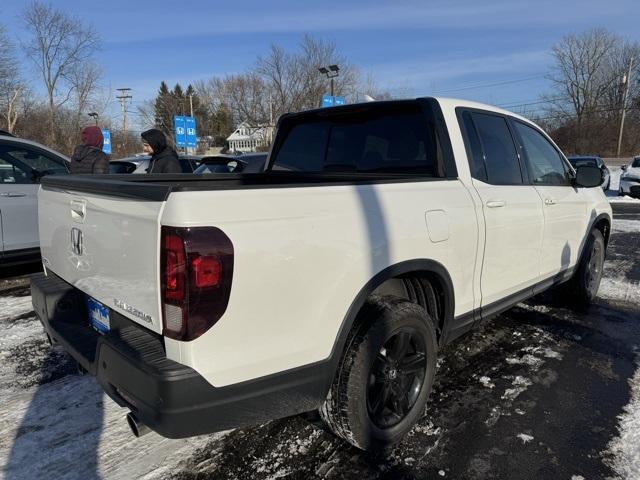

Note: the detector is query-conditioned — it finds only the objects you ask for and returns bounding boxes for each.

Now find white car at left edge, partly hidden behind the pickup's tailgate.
[0,132,69,265]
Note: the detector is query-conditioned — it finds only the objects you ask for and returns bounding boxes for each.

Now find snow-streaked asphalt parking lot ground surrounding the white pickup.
[0,203,640,480]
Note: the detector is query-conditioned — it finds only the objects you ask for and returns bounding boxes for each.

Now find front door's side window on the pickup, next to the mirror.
[513,121,568,185]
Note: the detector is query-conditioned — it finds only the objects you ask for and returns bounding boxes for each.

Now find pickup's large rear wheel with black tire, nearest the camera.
[320,296,437,450]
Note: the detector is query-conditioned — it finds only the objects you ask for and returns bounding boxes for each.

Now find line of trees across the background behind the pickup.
[0,0,640,156]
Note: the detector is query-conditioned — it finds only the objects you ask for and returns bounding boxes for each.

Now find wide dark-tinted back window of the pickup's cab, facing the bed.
[273,105,442,177]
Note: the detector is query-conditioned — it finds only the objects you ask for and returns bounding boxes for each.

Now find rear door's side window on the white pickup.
[471,112,523,185]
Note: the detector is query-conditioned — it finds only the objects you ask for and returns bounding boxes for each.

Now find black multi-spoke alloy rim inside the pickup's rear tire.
[367,328,427,429]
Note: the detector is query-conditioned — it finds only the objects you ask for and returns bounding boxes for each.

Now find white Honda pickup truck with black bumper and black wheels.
[32,98,611,449]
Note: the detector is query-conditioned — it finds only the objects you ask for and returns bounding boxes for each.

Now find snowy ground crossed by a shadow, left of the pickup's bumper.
[0,295,224,480]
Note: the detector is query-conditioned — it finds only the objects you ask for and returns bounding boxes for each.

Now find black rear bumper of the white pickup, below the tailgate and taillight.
[31,272,328,438]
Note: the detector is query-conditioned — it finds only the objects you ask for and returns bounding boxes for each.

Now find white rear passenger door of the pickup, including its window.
[459,110,544,310]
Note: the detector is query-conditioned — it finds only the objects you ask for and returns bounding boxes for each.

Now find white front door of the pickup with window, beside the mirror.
[511,119,589,279]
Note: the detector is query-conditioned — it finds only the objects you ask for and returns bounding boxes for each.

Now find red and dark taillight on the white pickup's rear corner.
[160,227,233,341]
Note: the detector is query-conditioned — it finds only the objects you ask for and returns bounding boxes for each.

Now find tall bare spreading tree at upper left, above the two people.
[23,1,100,141]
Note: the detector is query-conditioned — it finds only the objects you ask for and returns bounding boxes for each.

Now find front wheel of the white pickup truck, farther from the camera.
[568,229,606,309]
